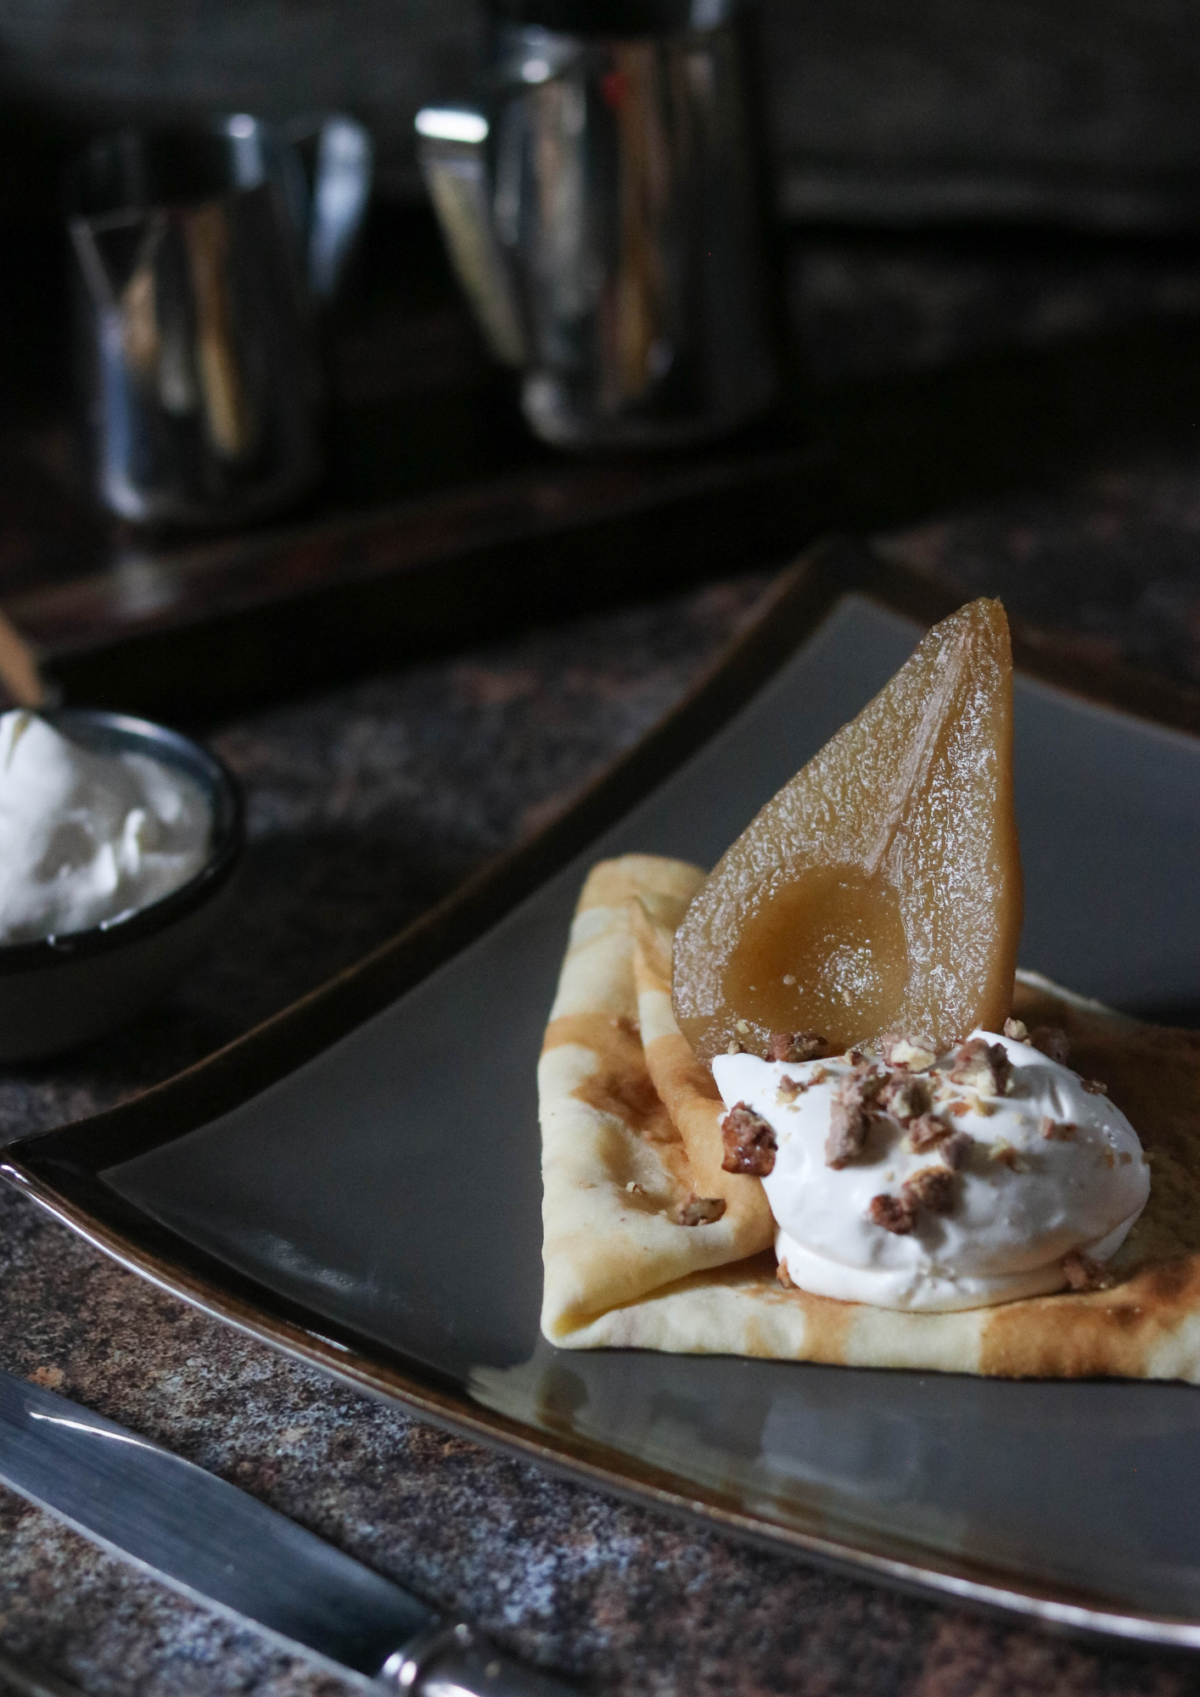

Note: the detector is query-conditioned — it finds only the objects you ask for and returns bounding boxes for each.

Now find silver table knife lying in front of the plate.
[0,1369,572,1697]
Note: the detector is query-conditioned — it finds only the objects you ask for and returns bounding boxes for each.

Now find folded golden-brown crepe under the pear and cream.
[538,855,1200,1383]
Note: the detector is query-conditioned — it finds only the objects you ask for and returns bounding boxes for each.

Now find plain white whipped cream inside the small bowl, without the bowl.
[0,709,212,944]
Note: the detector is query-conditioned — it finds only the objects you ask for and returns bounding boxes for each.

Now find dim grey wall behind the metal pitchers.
[0,0,1200,229]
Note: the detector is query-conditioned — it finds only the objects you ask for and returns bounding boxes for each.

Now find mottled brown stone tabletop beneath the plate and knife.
[9,481,1200,1697]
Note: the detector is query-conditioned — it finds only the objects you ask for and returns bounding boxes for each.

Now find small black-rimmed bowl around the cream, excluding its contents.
[0,708,246,1061]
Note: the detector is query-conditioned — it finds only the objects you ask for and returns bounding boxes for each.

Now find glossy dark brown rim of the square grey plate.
[9,538,1200,1649]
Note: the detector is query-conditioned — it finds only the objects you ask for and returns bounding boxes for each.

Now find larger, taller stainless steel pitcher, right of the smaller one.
[416,0,777,448]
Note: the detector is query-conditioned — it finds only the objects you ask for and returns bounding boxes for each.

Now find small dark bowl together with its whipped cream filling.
[0,708,244,1061]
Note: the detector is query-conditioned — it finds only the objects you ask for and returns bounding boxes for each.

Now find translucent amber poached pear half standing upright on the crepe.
[674,601,1022,1061]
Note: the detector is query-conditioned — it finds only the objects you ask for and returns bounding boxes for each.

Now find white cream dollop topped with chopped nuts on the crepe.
[713,1028,1149,1312]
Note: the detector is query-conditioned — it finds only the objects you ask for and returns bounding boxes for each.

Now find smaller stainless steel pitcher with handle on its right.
[70,114,370,524]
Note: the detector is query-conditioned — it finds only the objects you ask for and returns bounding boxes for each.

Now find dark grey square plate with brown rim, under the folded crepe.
[5,546,1200,1646]
